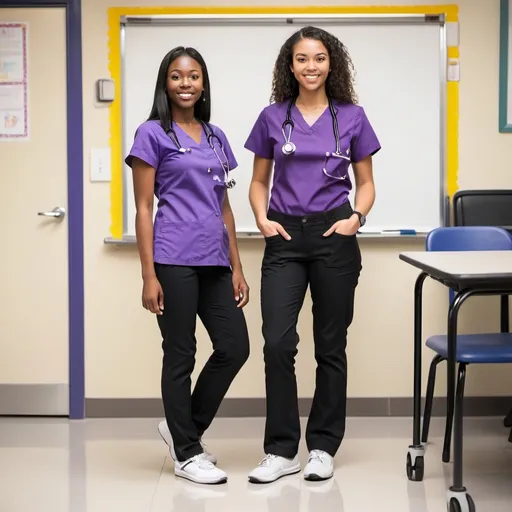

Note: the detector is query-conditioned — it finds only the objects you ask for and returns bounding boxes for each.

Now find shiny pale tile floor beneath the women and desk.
[0,418,512,512]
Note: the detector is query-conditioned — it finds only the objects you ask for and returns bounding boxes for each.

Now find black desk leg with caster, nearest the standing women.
[406,272,428,482]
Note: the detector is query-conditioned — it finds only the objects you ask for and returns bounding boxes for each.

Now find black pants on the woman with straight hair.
[155,264,249,462]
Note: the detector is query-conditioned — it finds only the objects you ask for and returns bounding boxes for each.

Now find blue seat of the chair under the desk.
[426,332,512,364]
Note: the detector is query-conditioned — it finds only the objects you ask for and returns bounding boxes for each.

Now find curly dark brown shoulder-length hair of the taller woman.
[270,27,357,103]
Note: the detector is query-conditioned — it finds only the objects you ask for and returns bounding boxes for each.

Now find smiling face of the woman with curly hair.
[290,39,330,91]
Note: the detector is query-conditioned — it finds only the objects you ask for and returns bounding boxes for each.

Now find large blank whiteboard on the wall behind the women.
[121,15,446,236]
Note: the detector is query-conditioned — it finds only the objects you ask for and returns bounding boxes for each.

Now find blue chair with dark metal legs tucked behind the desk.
[422,226,512,462]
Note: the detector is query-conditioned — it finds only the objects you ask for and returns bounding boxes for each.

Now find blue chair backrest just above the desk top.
[426,226,512,251]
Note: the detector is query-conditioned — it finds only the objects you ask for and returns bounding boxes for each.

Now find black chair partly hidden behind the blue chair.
[453,189,512,443]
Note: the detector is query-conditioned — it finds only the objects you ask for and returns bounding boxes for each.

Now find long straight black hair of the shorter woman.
[148,46,211,132]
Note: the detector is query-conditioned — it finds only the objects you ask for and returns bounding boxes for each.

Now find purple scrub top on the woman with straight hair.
[125,121,238,267]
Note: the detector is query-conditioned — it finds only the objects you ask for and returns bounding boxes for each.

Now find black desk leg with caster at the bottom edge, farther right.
[443,290,476,512]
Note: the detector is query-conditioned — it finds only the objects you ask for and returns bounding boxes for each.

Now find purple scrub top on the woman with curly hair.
[245,100,380,216]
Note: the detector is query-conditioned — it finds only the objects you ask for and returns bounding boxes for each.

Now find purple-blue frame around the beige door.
[0,0,85,419]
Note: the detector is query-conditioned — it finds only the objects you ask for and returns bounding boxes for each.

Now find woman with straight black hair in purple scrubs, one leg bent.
[126,47,249,484]
